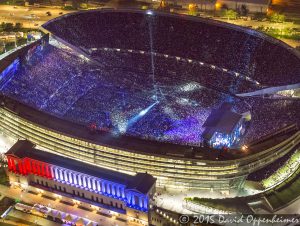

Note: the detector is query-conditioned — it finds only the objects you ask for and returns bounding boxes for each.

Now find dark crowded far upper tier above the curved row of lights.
[45,11,300,86]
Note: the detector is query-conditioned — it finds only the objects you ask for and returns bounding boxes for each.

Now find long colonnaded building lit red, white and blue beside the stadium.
[6,140,156,225]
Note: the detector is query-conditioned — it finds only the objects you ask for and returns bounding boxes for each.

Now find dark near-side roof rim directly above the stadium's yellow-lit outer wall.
[0,93,300,164]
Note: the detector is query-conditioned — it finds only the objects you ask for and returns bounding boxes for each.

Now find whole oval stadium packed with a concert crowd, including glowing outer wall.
[0,9,300,191]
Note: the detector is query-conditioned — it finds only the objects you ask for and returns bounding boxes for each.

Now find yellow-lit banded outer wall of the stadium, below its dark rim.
[0,107,300,191]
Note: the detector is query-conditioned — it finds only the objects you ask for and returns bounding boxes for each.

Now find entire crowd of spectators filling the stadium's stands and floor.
[1,12,300,145]
